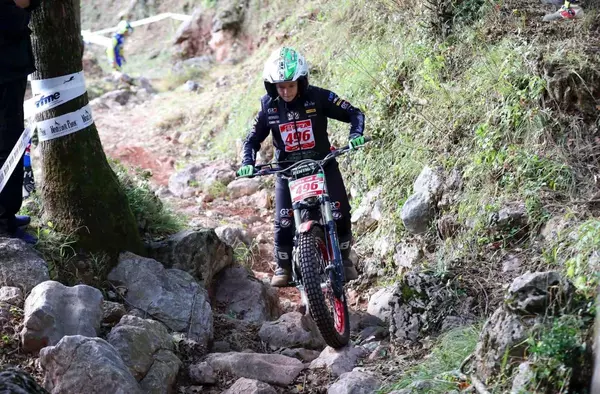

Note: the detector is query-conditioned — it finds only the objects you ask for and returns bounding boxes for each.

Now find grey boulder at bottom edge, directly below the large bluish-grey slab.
[108,315,181,394]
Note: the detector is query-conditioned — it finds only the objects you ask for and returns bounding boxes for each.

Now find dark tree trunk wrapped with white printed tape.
[31,0,142,256]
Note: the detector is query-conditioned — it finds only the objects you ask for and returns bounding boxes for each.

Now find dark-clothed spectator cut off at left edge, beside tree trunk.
[0,0,40,243]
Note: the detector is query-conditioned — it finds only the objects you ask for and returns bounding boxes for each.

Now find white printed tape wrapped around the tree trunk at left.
[0,71,94,192]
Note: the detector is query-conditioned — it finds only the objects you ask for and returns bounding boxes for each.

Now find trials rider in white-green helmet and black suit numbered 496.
[237,47,365,287]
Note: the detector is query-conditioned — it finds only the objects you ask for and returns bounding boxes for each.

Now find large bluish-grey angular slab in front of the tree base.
[108,252,213,345]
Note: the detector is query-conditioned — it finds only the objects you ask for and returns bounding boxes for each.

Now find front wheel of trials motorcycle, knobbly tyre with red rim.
[298,227,350,349]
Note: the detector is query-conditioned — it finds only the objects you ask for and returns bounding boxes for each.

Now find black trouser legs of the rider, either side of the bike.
[275,162,352,270]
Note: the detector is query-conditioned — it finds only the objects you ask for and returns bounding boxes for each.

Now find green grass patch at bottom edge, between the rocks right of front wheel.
[379,326,481,394]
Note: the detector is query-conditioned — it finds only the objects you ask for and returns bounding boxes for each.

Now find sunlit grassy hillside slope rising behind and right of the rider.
[75,0,600,393]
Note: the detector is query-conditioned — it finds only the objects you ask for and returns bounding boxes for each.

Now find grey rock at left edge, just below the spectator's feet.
[0,238,50,294]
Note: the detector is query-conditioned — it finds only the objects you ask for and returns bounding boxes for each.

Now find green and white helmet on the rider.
[263,47,308,97]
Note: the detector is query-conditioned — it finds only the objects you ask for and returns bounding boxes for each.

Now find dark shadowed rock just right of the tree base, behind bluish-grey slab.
[148,229,233,288]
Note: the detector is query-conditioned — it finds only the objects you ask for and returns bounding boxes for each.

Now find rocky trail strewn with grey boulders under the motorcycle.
[0,71,588,394]
